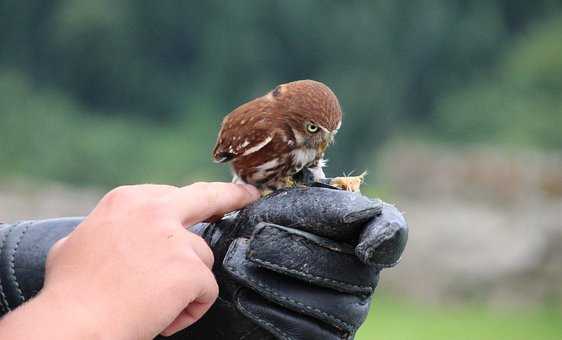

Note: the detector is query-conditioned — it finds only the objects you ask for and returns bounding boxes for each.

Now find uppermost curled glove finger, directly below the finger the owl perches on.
[246,223,379,296]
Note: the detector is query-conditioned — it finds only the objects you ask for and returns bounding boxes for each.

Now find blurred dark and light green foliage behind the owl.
[0,0,562,186]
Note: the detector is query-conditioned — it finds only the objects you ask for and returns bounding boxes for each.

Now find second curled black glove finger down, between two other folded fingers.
[223,238,369,332]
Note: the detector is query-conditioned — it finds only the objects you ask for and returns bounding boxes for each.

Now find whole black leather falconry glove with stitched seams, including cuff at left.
[0,188,407,340]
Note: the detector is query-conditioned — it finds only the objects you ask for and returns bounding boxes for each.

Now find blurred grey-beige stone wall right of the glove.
[378,144,562,305]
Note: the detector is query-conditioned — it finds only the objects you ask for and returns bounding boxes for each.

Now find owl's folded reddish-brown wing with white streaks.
[213,101,275,163]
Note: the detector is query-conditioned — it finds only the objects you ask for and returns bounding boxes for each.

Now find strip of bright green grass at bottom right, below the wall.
[357,297,562,340]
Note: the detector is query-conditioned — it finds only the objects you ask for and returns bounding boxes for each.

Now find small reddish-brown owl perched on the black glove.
[213,80,342,192]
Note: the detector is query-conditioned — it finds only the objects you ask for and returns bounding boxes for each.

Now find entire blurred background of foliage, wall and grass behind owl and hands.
[0,0,562,340]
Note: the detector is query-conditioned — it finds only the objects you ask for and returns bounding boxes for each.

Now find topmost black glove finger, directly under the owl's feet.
[236,187,382,240]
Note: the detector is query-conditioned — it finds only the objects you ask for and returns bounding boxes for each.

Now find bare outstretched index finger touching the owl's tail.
[171,182,260,226]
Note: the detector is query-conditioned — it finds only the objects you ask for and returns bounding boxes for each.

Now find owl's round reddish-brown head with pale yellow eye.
[265,80,342,152]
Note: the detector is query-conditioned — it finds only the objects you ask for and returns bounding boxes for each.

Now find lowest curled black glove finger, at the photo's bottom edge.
[236,289,350,340]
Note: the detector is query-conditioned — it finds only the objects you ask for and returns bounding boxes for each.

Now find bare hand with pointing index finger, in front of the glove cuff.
[0,183,260,340]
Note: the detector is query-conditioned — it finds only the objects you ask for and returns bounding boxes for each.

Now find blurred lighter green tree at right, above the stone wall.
[436,16,562,150]
